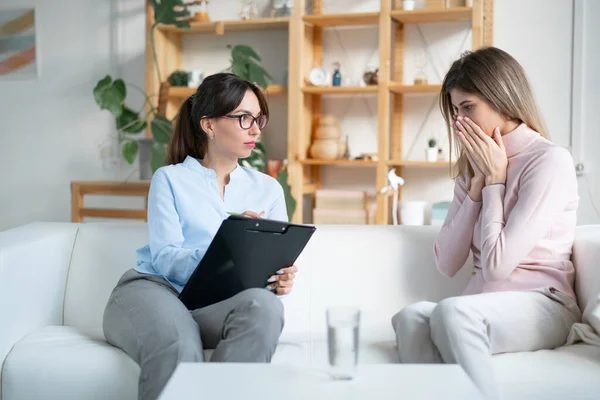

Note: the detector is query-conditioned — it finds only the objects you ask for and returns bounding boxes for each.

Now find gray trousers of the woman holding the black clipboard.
[103,269,284,400]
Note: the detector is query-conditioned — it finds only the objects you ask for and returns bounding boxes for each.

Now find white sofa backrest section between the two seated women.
[297,225,471,340]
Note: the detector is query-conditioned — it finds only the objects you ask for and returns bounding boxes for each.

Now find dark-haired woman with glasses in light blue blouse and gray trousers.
[103,73,297,399]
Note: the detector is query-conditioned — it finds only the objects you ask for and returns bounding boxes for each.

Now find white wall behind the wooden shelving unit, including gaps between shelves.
[0,0,600,230]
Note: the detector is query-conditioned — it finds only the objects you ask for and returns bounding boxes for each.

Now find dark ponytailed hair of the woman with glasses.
[166,73,269,165]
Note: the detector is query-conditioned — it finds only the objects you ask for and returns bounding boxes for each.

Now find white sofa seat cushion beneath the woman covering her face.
[493,343,600,400]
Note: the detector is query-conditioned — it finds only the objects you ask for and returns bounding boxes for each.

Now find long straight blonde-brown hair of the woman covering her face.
[440,47,550,177]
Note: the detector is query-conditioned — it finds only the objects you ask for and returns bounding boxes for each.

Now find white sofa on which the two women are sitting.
[0,222,600,400]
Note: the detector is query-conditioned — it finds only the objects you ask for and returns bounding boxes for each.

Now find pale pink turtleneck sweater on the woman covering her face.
[434,124,579,298]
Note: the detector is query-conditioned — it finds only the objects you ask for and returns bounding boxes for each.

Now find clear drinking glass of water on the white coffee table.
[327,307,360,380]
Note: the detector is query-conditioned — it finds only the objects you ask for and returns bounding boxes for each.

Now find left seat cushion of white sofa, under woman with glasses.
[2,326,309,400]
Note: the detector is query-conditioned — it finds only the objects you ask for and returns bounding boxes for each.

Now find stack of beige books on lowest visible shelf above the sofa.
[313,189,375,225]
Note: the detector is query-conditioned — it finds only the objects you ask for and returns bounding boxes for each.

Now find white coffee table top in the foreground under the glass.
[160,363,482,400]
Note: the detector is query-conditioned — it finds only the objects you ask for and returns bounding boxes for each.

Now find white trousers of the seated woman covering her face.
[392,288,581,399]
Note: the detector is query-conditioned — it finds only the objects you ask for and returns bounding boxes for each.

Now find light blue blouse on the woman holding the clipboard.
[135,156,288,292]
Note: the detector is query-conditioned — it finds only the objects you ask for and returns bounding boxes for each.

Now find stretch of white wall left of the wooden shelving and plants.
[0,0,144,229]
